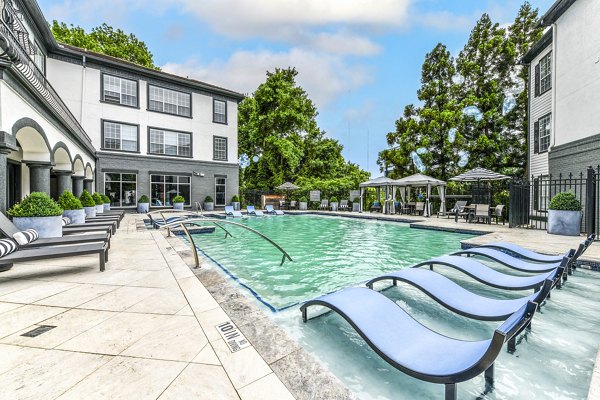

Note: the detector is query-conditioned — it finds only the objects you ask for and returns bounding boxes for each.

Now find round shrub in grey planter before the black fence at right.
[548,192,582,236]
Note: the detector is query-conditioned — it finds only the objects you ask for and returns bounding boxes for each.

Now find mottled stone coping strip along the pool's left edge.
[166,231,358,400]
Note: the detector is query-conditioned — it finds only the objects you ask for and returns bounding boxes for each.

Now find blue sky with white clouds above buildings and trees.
[38,0,553,177]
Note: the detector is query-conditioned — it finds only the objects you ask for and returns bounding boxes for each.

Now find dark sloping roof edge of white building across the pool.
[53,43,245,101]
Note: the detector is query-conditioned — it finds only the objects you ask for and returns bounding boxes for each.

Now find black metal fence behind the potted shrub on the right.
[509,165,600,235]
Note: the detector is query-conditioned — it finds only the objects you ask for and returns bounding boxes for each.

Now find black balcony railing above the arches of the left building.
[0,19,92,147]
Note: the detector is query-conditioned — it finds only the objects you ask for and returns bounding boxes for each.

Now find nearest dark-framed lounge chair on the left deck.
[0,239,108,271]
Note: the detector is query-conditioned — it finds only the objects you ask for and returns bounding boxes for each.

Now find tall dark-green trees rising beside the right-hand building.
[378,3,541,180]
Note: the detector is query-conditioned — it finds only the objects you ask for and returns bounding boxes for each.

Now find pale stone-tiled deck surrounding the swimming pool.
[0,212,600,400]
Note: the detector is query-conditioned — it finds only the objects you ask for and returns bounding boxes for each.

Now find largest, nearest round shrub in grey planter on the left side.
[8,192,63,238]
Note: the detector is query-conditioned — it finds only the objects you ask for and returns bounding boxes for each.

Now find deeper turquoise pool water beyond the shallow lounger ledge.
[194,215,472,310]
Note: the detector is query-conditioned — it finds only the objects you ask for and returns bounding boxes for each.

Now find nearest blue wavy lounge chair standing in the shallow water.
[300,288,537,400]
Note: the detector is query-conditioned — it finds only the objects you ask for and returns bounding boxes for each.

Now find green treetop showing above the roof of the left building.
[51,20,158,69]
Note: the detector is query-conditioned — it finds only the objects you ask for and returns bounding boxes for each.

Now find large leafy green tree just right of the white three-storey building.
[238,68,369,197]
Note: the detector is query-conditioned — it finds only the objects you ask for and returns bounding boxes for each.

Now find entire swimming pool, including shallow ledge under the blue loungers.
[189,216,600,399]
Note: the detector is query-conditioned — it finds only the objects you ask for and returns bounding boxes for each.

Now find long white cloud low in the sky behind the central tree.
[161,48,373,107]
